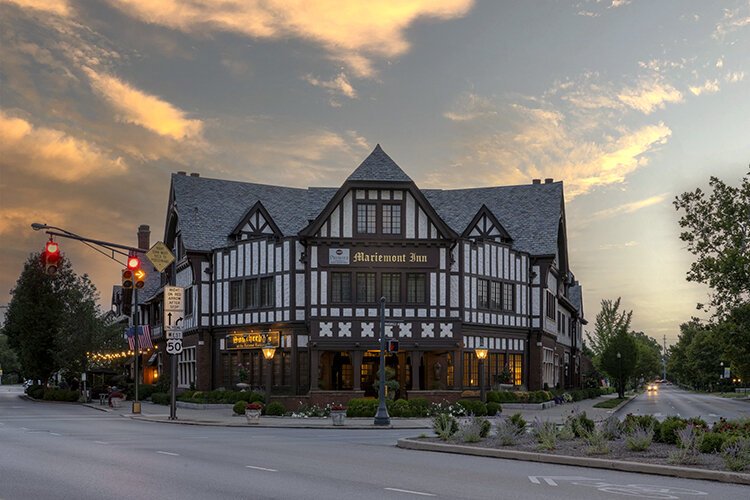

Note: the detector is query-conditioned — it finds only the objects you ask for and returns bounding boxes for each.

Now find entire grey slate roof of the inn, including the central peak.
[172,145,563,255]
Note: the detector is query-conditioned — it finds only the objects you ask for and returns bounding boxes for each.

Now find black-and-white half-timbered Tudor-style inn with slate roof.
[142,146,585,397]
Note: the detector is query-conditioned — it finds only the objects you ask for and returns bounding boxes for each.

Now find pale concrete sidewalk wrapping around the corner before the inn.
[85,394,628,429]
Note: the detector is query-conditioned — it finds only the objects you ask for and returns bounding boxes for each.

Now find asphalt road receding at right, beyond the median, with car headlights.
[617,384,750,425]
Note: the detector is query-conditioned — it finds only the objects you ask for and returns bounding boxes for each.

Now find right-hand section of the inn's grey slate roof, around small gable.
[422,182,563,255]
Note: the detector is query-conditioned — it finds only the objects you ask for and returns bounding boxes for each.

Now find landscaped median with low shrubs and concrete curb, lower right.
[398,413,750,485]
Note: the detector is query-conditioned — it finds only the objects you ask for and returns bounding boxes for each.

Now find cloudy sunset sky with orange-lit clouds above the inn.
[0,0,750,344]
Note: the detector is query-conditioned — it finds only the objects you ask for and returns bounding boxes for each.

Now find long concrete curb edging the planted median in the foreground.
[396,438,750,485]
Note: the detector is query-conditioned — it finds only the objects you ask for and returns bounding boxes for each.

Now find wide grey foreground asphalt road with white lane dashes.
[0,387,748,500]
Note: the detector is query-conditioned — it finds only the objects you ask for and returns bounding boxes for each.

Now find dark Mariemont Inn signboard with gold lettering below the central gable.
[328,247,439,268]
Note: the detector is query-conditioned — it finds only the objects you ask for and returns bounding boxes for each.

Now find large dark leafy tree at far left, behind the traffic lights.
[4,254,115,384]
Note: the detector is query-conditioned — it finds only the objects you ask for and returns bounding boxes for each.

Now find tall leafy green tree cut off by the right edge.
[673,172,750,317]
